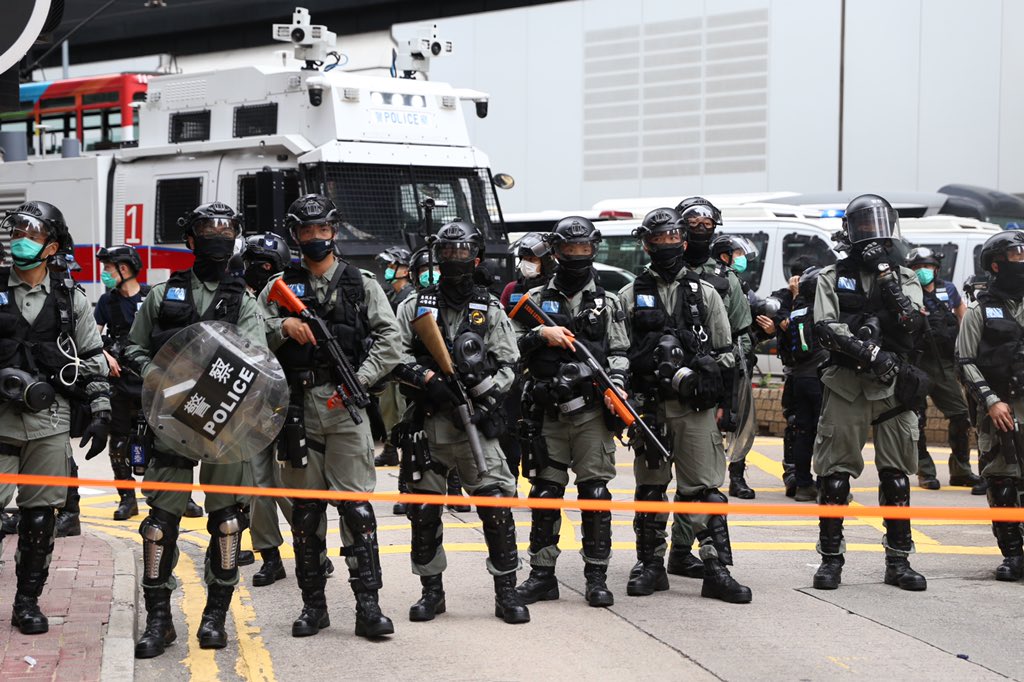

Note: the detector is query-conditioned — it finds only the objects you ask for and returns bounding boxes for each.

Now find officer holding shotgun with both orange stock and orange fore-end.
[514,216,630,606]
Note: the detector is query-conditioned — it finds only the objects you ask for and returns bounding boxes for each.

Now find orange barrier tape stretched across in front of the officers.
[0,474,1024,522]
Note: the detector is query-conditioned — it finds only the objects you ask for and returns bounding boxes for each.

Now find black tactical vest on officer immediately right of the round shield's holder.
[275,260,373,376]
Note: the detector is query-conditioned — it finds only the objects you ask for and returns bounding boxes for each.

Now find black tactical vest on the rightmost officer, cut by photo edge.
[974,290,1024,400]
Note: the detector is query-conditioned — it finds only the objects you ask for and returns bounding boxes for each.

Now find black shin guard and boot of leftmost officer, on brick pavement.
[10,507,54,635]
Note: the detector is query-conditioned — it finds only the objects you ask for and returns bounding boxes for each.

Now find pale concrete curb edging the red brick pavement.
[94,531,138,682]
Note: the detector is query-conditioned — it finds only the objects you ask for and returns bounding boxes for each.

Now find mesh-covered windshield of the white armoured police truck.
[304,163,505,244]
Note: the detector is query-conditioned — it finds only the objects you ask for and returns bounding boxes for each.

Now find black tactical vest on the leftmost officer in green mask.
[0,267,76,388]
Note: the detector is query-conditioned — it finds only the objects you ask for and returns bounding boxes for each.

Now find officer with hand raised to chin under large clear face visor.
[814,195,928,591]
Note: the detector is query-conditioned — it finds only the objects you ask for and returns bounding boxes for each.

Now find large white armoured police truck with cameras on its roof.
[0,8,508,298]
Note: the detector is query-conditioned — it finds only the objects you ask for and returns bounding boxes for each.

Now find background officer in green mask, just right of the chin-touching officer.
[907,247,985,495]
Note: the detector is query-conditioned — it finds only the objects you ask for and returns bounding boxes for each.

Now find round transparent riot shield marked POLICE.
[142,322,288,464]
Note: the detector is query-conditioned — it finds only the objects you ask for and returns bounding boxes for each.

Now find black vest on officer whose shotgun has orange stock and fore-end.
[526,280,610,381]
